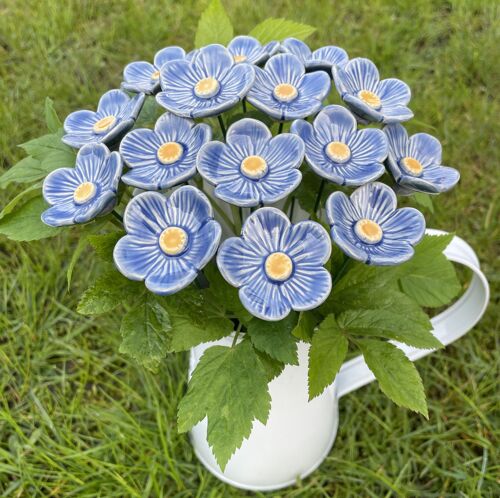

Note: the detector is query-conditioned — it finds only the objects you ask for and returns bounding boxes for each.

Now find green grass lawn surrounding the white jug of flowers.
[0,0,500,497]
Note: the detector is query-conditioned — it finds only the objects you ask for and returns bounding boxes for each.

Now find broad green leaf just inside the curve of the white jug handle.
[398,234,460,308]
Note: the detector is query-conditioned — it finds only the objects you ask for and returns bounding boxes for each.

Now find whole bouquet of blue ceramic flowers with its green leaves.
[0,4,459,465]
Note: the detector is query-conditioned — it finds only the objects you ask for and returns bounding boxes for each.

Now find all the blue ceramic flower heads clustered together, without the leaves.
[42,36,459,320]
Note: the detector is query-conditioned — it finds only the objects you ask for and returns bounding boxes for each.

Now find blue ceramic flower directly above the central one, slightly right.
[247,54,330,120]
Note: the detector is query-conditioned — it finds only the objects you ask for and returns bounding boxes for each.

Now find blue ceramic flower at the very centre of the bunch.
[197,118,304,207]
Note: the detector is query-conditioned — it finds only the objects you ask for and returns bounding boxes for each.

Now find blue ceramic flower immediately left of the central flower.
[120,113,212,190]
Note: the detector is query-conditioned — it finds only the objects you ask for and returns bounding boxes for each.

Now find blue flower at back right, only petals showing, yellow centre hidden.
[281,38,349,72]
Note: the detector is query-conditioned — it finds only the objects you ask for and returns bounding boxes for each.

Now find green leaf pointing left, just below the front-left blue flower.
[77,268,143,315]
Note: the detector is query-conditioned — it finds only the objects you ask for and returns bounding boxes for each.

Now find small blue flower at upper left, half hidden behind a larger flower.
[122,46,186,94]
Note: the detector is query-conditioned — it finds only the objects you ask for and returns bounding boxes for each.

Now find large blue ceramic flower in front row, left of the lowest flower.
[113,186,221,295]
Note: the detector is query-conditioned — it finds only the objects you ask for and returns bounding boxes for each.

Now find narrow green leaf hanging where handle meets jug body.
[308,315,348,400]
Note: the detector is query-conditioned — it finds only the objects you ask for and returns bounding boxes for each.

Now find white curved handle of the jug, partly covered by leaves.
[335,229,490,397]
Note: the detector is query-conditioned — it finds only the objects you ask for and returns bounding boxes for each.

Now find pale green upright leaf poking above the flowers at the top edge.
[194,0,233,48]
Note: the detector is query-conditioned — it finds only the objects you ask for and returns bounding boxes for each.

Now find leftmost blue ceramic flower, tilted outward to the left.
[42,144,122,227]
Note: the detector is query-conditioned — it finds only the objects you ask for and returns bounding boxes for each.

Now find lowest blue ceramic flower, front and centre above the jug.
[217,207,332,320]
